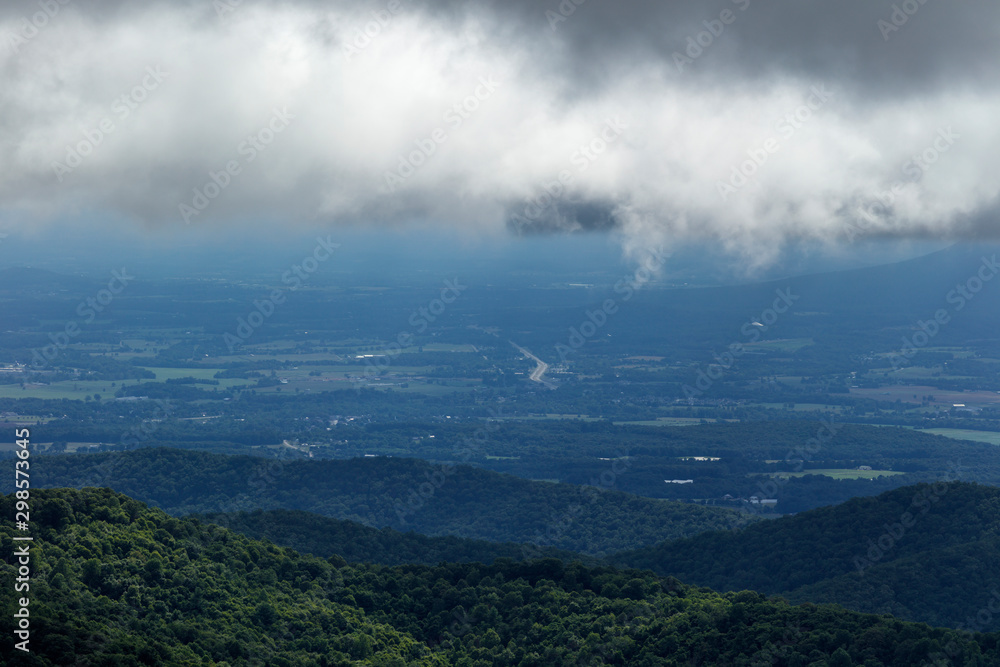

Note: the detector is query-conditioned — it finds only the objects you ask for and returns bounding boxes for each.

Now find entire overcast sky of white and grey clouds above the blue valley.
[0,0,1000,265]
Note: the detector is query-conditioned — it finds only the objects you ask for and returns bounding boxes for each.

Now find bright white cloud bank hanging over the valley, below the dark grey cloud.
[0,3,1000,265]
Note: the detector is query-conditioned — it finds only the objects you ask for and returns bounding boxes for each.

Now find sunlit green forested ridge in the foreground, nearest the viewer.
[0,489,1000,667]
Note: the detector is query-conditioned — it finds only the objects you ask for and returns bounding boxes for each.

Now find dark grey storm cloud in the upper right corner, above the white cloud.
[518,0,1000,97]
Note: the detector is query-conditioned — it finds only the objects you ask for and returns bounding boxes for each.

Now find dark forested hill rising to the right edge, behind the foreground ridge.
[611,482,1000,629]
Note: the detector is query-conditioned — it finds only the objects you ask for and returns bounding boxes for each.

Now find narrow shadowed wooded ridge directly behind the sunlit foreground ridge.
[192,510,597,565]
